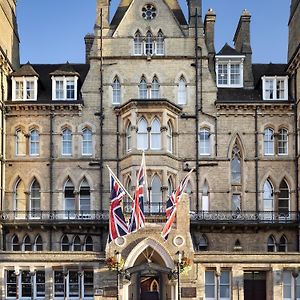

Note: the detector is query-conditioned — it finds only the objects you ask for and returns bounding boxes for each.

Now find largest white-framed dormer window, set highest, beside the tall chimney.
[216,56,244,88]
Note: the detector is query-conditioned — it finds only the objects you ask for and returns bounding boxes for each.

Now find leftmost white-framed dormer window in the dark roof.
[12,76,38,101]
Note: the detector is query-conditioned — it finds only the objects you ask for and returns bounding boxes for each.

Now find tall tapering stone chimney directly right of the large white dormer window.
[233,9,254,88]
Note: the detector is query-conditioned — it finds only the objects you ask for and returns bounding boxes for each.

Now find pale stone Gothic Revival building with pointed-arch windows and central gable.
[0,0,300,300]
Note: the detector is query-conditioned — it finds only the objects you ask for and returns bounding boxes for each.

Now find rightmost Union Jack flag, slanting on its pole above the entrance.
[161,169,194,241]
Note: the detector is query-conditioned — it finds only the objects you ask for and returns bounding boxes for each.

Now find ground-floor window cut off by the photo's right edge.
[282,270,300,300]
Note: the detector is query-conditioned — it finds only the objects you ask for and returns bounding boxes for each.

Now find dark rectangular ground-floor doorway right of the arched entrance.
[244,271,267,300]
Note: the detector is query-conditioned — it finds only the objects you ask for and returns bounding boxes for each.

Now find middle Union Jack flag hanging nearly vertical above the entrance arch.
[129,152,146,233]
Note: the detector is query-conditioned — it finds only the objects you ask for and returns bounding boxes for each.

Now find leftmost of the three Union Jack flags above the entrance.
[108,172,128,243]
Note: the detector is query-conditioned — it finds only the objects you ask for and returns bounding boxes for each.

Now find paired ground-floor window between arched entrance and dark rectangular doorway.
[205,270,231,300]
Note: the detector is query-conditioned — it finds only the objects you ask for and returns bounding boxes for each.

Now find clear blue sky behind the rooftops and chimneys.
[17,0,290,64]
